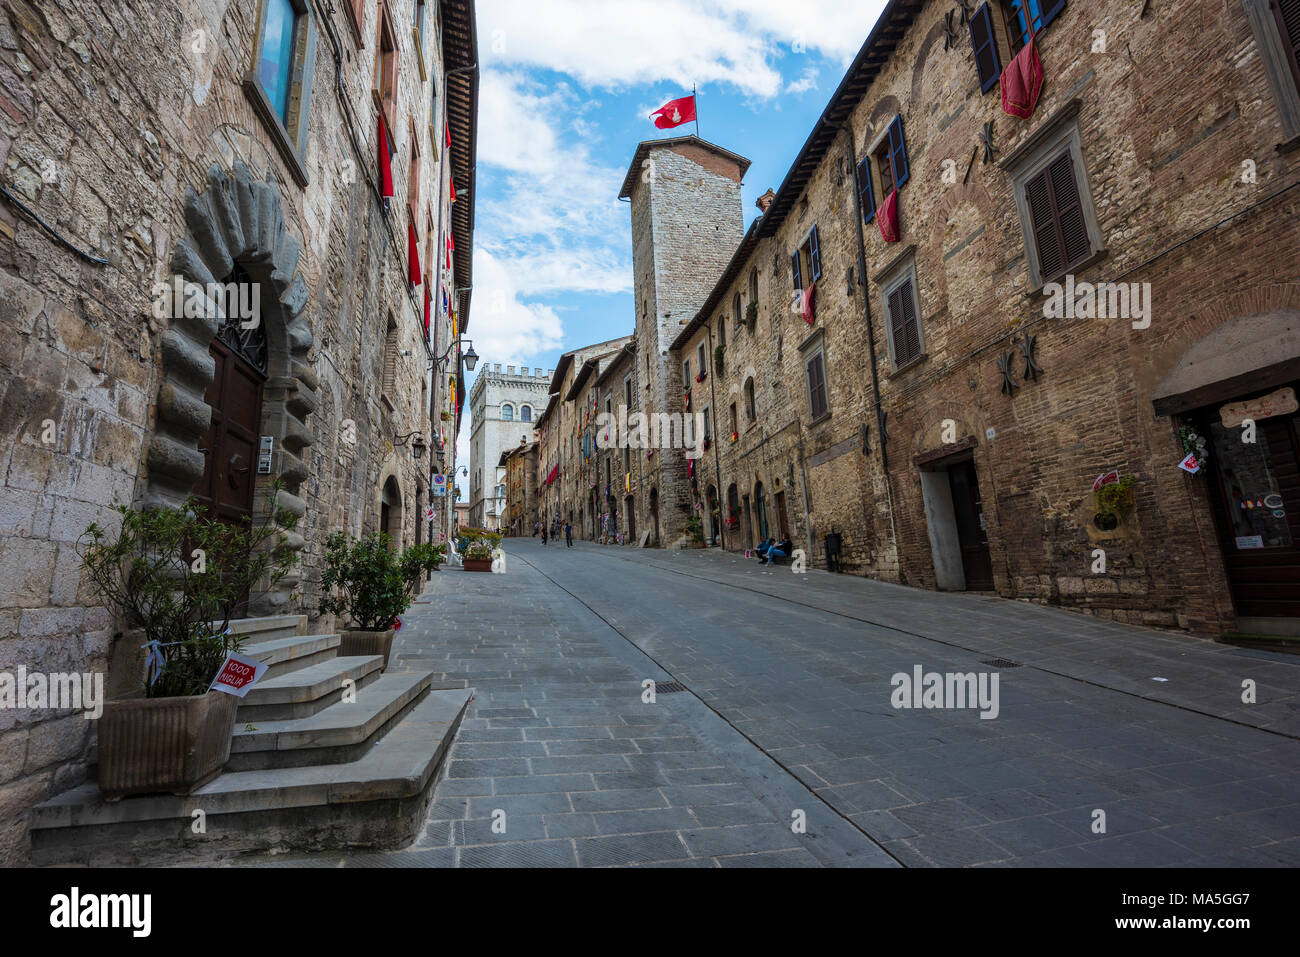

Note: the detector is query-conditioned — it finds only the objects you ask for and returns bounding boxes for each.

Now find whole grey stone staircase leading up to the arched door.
[31,615,473,865]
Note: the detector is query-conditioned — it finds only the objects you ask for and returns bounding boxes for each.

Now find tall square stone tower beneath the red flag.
[619,137,749,545]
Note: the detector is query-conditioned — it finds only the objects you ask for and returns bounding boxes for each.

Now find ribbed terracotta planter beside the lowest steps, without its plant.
[98,692,239,801]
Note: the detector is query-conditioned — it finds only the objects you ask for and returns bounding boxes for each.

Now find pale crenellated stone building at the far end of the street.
[469,363,554,531]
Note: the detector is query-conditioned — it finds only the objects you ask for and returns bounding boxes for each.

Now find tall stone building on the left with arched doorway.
[0,0,477,863]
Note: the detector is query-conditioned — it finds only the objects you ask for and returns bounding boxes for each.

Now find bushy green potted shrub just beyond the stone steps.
[320,532,442,670]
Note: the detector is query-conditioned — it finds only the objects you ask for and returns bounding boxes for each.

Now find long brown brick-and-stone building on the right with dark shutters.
[655,0,1300,635]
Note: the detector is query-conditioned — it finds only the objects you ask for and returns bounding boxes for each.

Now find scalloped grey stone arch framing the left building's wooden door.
[142,160,319,605]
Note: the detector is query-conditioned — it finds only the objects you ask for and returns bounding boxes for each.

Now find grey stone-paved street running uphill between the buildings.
[247,538,1300,867]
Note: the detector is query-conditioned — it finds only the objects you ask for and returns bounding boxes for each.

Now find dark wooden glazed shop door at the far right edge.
[1203,397,1300,618]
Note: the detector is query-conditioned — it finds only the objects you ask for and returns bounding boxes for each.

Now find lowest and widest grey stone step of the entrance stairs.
[31,690,473,866]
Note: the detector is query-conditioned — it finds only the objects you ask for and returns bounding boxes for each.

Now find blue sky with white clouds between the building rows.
[458,0,884,501]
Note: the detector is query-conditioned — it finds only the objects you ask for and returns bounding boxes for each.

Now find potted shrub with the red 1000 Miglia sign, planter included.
[78,494,295,801]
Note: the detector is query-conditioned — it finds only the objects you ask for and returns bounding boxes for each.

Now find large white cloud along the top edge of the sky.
[478,0,885,98]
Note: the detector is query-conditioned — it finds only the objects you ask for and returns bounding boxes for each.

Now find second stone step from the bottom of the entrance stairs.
[226,671,433,771]
